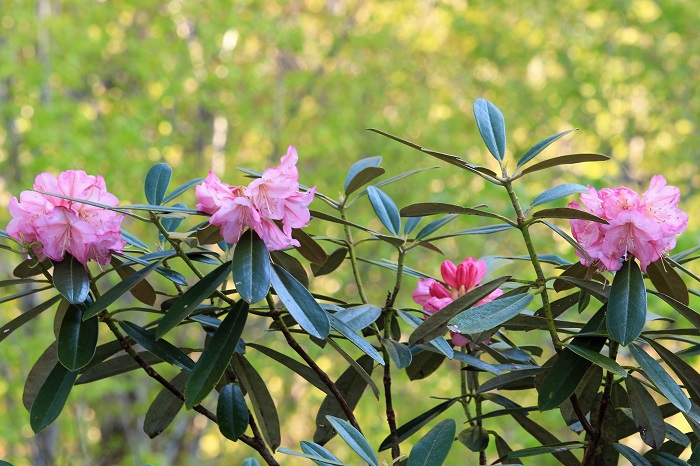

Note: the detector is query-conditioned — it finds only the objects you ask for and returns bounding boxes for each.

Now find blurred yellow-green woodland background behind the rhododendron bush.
[0,0,700,466]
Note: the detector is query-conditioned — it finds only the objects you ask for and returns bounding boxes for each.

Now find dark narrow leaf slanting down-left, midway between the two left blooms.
[156,262,231,338]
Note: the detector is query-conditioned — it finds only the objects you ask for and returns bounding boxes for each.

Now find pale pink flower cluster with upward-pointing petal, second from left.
[196,146,316,251]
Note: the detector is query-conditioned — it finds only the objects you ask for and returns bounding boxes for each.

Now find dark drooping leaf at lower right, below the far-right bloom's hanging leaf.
[625,377,666,449]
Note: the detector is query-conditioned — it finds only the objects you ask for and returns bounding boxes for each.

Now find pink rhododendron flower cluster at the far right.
[569,175,688,271]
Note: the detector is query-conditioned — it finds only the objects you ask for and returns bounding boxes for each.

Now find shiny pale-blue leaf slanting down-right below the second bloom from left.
[271,264,331,339]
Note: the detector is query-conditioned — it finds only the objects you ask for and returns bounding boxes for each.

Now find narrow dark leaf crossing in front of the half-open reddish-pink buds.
[408,277,510,346]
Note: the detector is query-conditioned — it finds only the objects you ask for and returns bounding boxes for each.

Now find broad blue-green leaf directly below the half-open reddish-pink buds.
[447,288,534,334]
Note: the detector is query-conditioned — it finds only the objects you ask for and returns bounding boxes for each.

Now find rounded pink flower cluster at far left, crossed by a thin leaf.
[7,170,126,265]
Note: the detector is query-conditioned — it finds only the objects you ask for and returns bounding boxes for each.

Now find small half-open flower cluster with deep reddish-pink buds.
[413,257,503,346]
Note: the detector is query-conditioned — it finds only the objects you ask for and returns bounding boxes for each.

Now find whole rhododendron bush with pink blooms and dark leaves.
[0,99,700,466]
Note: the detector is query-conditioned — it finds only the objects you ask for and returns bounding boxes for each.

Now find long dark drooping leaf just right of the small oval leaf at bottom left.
[231,353,281,451]
